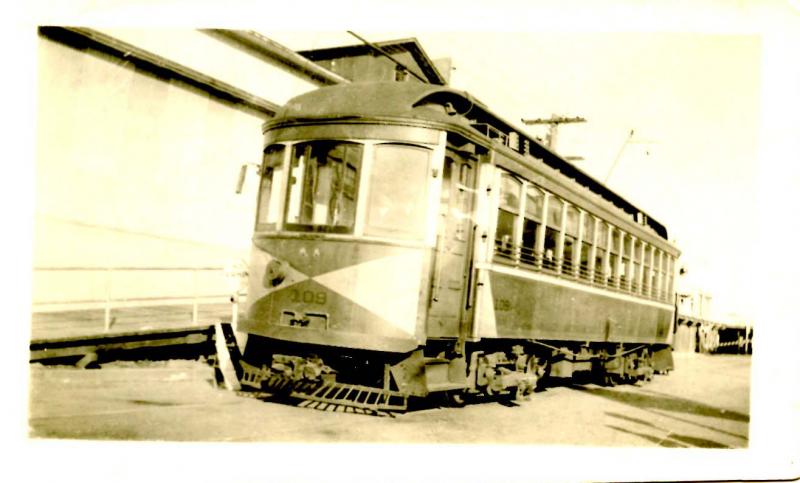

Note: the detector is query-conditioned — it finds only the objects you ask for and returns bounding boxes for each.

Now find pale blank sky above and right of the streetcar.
[265,30,762,322]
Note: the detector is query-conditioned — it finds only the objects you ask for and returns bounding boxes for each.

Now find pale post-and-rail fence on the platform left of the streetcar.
[33,267,246,332]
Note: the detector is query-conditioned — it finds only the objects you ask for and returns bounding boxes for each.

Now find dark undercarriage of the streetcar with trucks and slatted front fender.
[216,328,672,413]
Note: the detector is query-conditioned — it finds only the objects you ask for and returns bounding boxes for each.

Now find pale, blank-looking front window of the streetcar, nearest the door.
[364,144,431,240]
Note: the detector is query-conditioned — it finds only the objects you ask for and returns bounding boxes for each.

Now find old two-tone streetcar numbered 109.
[237,82,680,410]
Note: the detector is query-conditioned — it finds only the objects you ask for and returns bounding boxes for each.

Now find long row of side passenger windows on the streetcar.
[495,170,674,300]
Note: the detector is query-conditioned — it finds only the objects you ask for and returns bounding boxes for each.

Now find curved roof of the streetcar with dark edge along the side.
[265,82,668,244]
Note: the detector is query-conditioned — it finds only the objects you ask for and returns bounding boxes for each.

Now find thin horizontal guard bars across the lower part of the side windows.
[493,240,669,302]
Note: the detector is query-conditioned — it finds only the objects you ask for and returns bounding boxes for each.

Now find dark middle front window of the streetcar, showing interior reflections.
[286,141,363,233]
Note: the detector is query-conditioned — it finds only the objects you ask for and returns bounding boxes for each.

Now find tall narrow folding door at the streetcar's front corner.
[428,149,477,338]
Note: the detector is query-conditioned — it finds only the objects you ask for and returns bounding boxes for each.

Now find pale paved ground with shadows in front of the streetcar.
[29,354,750,448]
